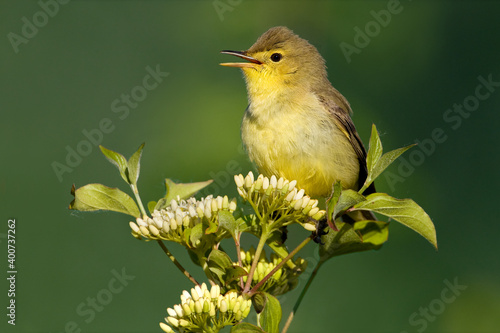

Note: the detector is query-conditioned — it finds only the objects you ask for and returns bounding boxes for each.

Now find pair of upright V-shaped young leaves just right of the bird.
[359,124,416,193]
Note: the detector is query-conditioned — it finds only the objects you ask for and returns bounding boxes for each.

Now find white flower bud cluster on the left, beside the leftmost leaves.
[130,195,236,247]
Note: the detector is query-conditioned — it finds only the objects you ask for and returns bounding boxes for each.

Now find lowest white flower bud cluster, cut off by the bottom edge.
[160,283,252,332]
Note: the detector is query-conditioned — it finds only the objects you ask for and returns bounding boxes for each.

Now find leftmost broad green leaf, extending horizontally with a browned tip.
[69,184,141,218]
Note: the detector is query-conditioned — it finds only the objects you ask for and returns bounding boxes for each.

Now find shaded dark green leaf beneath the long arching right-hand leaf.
[319,221,389,262]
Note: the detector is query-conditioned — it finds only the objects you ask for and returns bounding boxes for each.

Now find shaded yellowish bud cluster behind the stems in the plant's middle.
[236,246,307,296]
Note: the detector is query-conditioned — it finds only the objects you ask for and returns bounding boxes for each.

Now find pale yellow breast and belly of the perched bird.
[241,94,359,197]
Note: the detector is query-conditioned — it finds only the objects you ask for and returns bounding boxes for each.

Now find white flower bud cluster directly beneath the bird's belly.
[234,171,326,231]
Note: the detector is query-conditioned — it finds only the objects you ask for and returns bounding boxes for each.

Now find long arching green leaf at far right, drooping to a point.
[354,193,437,249]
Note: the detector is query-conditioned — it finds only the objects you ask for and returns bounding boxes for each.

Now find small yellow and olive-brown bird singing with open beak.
[221,27,374,214]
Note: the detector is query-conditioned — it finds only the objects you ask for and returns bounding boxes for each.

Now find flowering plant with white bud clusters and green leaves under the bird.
[69,126,437,333]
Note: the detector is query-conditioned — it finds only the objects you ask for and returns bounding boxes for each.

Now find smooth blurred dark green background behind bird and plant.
[0,0,500,333]
